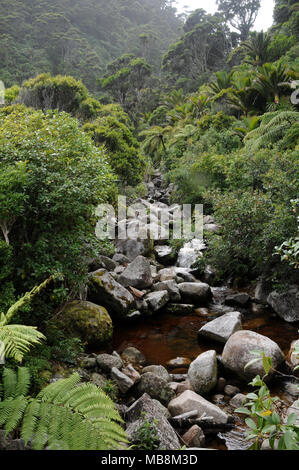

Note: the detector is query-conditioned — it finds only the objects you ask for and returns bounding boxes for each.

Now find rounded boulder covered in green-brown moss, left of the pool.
[60,300,113,346]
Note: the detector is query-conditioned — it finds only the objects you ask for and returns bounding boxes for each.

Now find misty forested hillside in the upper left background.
[0,0,181,90]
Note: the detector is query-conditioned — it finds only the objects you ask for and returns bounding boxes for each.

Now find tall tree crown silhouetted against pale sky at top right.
[217,0,261,41]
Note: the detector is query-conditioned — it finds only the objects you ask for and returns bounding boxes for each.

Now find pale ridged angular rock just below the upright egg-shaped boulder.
[168,390,229,424]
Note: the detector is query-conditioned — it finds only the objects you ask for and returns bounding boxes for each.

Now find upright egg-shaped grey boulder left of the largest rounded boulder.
[188,351,217,395]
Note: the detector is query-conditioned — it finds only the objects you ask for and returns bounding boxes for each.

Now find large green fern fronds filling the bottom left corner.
[0,368,127,450]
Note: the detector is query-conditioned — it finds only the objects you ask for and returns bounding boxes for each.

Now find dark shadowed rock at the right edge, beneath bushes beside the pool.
[267,286,299,323]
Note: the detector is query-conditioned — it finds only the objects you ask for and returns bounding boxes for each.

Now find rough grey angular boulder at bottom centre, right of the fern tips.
[126,393,181,450]
